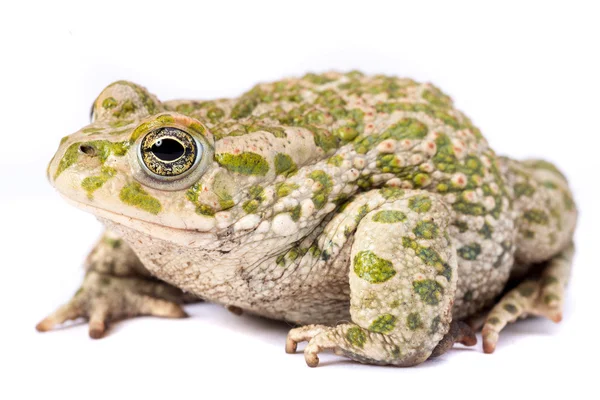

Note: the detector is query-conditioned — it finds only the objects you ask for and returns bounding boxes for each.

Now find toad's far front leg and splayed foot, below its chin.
[36,271,192,339]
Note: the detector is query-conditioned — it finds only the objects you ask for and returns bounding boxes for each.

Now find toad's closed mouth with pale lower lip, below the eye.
[61,194,219,249]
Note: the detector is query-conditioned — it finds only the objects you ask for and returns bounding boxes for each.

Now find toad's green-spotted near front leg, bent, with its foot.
[286,191,475,367]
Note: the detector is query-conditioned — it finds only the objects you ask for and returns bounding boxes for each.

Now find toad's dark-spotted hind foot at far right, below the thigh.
[481,244,574,353]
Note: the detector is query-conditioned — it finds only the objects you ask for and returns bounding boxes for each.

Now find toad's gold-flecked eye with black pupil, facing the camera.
[138,128,203,180]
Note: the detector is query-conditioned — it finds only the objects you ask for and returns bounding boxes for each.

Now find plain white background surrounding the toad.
[0,0,600,399]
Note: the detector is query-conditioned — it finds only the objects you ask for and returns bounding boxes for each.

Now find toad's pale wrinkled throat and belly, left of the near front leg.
[103,221,350,324]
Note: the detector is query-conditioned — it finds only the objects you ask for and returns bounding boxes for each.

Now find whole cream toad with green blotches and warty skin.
[38,72,577,366]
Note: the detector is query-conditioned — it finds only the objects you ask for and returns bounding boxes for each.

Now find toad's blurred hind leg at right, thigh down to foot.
[482,158,577,353]
